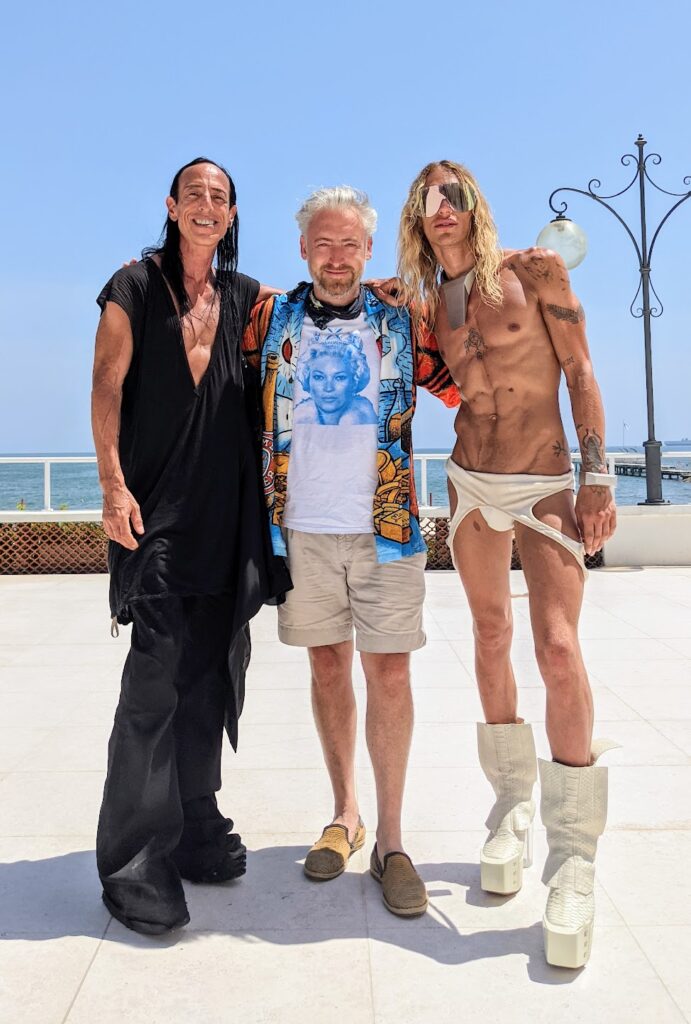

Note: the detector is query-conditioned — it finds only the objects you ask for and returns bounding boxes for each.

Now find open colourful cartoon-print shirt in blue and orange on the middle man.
[243,283,461,562]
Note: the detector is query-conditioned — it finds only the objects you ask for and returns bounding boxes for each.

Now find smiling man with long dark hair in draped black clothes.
[92,158,290,934]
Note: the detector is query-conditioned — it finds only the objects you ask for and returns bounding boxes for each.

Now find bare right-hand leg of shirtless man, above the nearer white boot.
[516,492,593,767]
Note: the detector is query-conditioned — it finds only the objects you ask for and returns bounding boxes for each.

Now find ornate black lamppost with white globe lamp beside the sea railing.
[537,135,691,505]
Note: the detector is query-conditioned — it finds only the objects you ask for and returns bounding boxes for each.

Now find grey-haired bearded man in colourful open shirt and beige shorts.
[244,186,460,916]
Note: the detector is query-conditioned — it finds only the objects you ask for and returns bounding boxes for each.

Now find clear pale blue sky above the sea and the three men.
[0,0,691,452]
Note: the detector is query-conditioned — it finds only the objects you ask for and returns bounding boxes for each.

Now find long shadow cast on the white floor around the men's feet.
[0,846,579,985]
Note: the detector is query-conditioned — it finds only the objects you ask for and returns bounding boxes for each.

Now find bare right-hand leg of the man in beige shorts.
[360,651,413,859]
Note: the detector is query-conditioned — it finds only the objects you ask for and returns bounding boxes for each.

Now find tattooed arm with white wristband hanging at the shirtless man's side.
[523,249,616,555]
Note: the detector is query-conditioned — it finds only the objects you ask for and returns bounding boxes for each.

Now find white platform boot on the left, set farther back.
[477,722,537,896]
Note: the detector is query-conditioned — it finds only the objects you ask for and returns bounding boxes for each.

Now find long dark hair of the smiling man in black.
[141,157,240,316]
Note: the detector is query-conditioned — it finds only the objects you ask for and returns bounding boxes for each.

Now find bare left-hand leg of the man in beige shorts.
[308,640,359,842]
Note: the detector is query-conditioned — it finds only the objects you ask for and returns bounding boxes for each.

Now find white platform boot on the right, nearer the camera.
[538,740,618,968]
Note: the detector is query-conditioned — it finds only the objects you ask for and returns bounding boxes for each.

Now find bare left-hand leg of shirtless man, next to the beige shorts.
[449,503,517,725]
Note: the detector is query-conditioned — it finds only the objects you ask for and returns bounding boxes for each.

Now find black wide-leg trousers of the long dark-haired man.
[96,595,233,927]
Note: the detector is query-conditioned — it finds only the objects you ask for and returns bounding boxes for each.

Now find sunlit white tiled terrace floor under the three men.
[0,567,691,1024]
